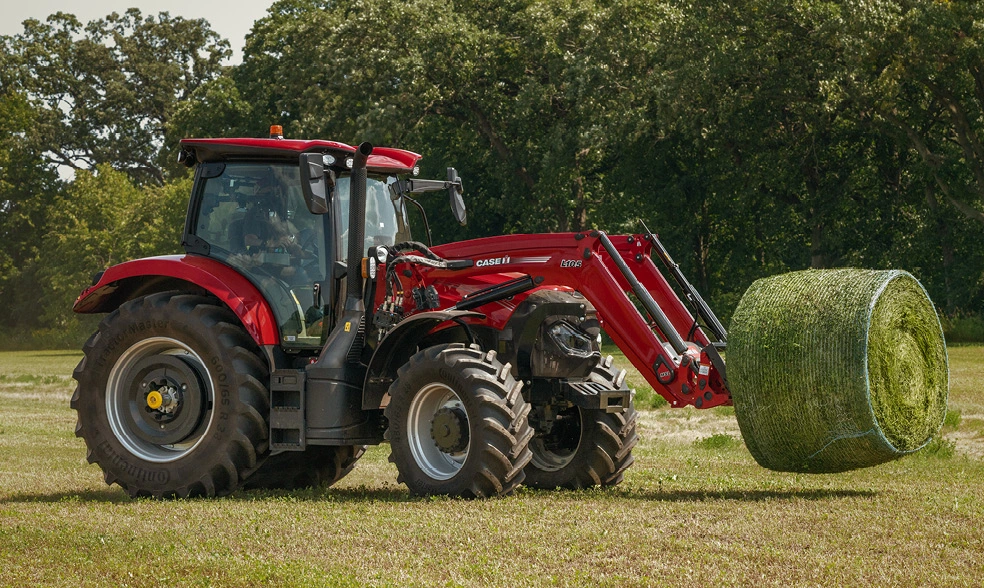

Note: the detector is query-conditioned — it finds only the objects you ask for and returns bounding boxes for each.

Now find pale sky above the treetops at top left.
[0,0,274,64]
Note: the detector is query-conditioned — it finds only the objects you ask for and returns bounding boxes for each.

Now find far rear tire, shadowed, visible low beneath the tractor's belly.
[243,445,366,490]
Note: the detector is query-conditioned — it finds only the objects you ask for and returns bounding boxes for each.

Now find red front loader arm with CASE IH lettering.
[412,231,731,408]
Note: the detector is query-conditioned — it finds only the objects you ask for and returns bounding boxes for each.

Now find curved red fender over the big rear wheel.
[72,255,280,347]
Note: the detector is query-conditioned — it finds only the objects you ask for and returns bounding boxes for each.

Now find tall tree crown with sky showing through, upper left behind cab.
[4,8,230,184]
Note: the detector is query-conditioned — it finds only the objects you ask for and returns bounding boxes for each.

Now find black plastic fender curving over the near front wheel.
[362,310,485,410]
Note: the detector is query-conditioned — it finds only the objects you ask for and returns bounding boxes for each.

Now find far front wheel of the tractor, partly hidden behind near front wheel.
[524,356,639,489]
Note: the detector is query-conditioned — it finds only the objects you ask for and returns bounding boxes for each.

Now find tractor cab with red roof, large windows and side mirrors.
[179,128,464,353]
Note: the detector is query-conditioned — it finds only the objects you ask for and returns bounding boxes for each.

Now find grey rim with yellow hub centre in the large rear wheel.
[106,337,213,463]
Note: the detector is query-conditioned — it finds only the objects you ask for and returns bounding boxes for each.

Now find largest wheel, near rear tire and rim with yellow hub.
[71,292,269,498]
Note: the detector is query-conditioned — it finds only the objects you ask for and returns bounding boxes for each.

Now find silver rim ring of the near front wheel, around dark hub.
[407,383,471,480]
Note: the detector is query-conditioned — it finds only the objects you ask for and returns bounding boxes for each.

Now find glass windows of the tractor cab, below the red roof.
[186,161,410,350]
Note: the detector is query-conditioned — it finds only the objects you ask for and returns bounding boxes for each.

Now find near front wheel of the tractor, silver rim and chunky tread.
[386,344,533,498]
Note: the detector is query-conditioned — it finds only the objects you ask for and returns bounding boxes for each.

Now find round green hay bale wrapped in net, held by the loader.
[727,269,949,473]
